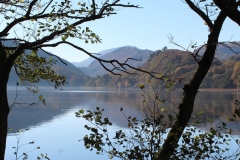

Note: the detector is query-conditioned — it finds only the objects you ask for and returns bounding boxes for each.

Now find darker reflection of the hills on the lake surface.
[9,88,240,132]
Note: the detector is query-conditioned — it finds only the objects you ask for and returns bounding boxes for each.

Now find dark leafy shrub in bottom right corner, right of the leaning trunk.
[172,120,240,160]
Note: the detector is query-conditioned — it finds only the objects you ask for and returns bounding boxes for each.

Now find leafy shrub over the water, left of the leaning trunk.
[76,80,174,159]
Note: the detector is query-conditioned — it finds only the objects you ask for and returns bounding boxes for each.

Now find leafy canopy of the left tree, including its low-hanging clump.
[0,0,138,90]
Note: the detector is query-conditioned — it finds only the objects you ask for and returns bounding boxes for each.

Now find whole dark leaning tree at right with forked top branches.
[79,0,240,160]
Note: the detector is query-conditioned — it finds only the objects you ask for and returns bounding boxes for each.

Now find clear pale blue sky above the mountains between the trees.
[46,0,240,62]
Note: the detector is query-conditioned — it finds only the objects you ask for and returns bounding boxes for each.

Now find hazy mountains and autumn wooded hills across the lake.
[7,42,240,88]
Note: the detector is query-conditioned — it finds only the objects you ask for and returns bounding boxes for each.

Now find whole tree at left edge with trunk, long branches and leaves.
[0,0,142,160]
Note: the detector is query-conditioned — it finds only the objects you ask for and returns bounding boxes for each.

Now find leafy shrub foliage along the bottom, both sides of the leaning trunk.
[76,84,240,160]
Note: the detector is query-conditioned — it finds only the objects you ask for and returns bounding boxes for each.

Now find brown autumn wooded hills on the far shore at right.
[82,49,240,88]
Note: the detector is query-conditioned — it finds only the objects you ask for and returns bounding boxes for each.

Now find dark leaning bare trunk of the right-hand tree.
[155,12,226,160]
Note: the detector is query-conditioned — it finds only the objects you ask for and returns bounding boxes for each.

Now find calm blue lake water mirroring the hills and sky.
[6,87,240,160]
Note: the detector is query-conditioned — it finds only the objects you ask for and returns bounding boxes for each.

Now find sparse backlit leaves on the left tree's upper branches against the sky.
[1,0,100,43]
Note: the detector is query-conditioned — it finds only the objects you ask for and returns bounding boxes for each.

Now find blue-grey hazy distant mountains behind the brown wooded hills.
[5,44,152,86]
